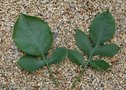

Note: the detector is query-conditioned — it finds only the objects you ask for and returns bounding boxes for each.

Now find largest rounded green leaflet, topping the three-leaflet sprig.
[13,14,53,56]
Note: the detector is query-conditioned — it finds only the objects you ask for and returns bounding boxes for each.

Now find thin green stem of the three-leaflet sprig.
[42,53,59,86]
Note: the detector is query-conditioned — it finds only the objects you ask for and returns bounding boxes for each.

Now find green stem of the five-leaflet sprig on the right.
[71,44,98,90]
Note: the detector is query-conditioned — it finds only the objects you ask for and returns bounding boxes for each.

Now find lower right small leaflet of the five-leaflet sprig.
[89,60,111,70]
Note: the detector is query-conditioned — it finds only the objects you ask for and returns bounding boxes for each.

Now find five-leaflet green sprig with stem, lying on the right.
[68,11,120,89]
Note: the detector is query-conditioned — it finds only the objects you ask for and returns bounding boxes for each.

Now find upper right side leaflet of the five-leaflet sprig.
[94,44,120,56]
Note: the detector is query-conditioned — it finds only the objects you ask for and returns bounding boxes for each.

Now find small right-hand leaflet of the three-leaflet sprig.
[48,47,67,64]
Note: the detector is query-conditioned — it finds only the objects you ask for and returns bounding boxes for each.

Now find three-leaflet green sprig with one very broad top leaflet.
[13,14,67,85]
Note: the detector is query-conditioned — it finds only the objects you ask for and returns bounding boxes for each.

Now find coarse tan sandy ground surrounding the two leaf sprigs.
[0,0,126,90]
